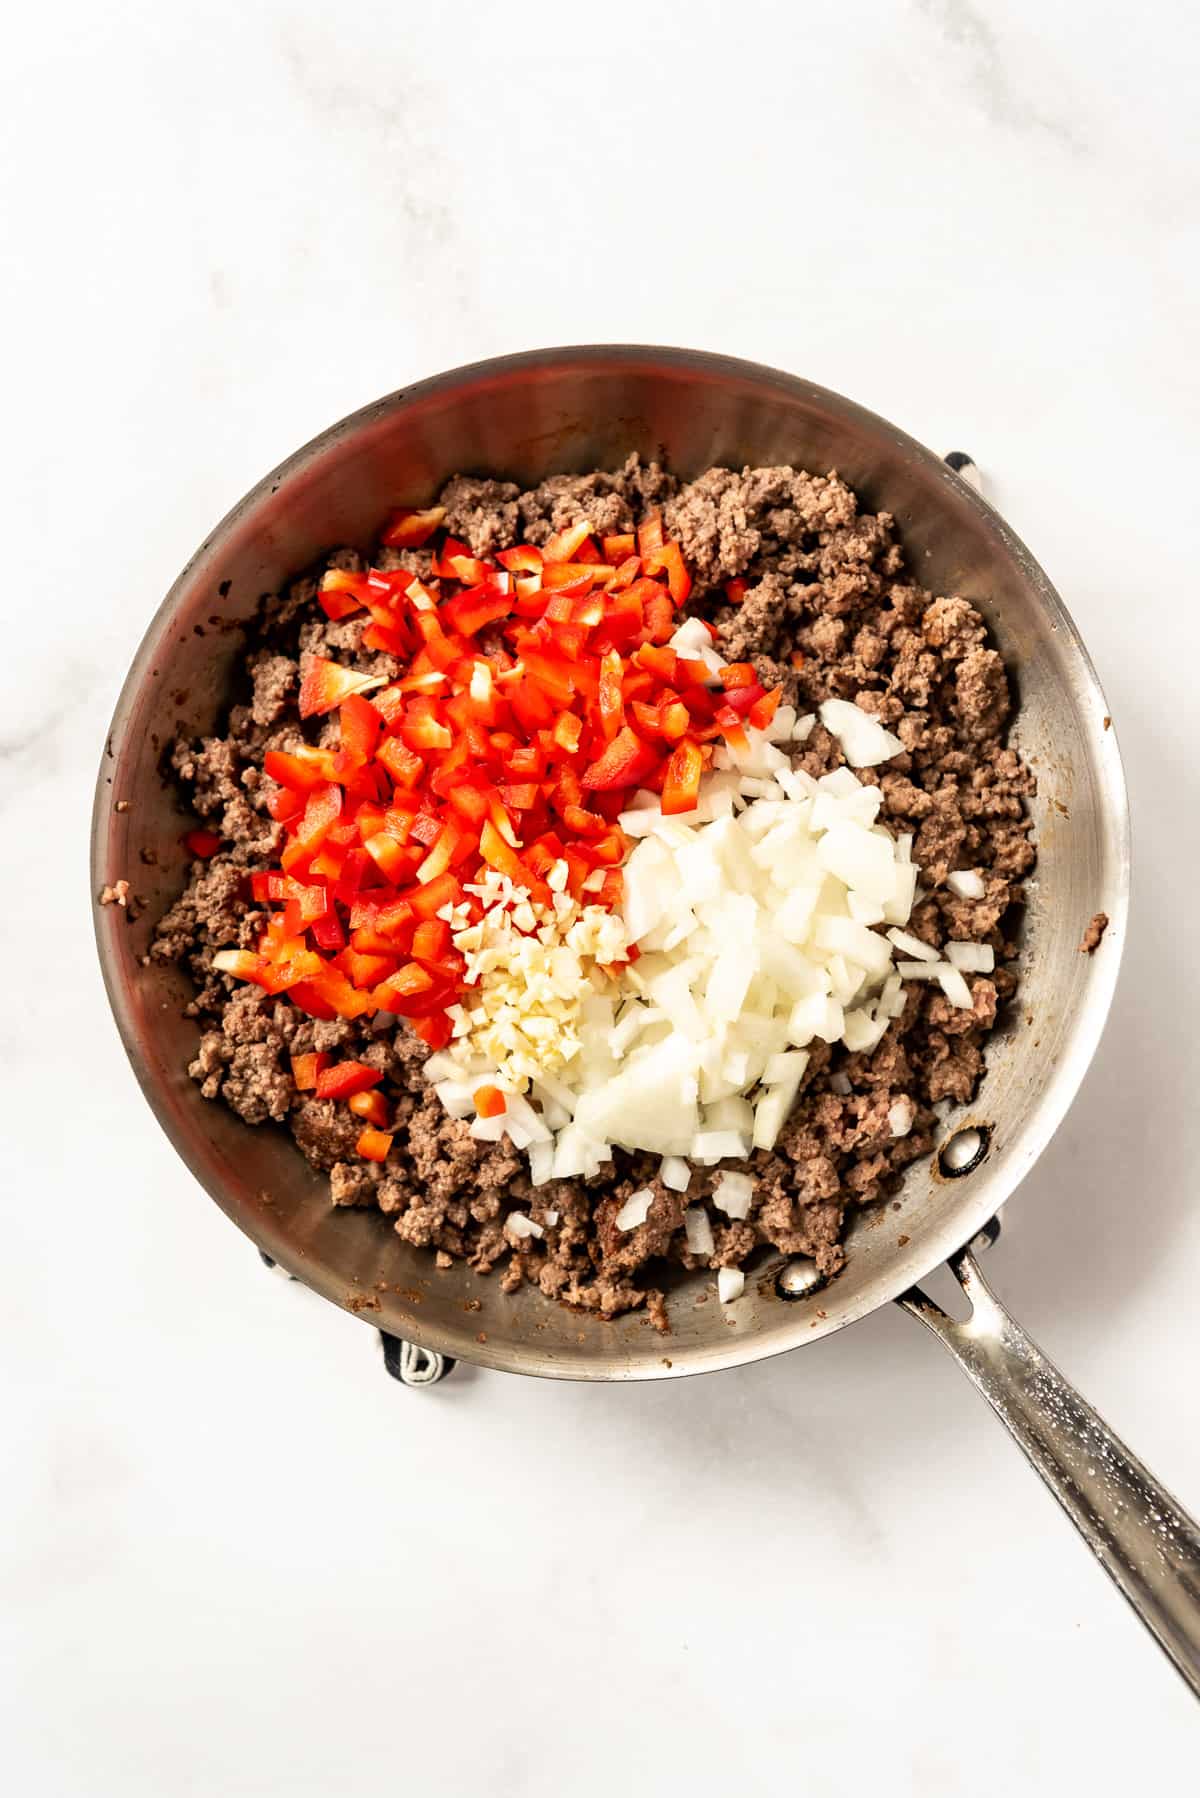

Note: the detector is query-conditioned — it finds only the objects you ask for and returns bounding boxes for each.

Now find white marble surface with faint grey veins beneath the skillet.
[0,0,1200,1798]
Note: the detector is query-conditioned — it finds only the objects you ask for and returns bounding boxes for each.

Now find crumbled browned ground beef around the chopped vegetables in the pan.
[153,457,1036,1325]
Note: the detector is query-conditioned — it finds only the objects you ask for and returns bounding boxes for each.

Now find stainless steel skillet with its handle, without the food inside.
[92,345,1200,1692]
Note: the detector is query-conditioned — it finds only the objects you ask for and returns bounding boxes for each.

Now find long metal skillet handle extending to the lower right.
[896,1248,1200,1697]
